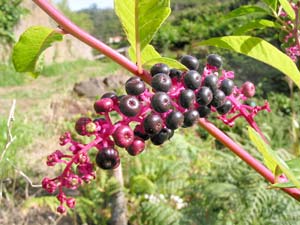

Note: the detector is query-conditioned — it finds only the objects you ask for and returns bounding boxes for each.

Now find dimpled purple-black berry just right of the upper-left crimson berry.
[119,95,141,117]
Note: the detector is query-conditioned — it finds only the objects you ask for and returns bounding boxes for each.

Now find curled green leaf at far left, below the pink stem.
[12,26,63,77]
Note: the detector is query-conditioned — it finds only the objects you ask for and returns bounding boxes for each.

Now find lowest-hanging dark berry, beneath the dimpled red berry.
[96,147,120,170]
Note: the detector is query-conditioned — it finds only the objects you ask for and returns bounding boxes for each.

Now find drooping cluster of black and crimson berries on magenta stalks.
[42,54,269,213]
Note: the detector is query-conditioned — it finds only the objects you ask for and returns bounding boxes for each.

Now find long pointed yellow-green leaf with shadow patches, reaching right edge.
[199,36,300,87]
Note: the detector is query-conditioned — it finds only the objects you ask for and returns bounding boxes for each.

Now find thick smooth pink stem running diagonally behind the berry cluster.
[33,0,300,200]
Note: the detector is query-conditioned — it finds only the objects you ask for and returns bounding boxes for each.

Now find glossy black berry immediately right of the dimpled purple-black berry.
[151,92,171,113]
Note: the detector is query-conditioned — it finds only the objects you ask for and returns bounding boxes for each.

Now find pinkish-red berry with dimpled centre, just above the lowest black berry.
[112,125,134,148]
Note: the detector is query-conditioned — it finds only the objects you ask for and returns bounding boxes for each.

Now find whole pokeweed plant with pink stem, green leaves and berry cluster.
[13,0,300,213]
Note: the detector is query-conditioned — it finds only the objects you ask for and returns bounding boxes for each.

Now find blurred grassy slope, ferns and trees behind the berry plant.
[0,0,300,225]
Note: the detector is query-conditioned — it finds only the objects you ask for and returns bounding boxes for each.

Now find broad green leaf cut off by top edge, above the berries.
[114,0,171,58]
